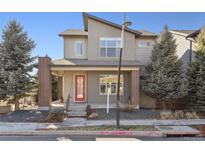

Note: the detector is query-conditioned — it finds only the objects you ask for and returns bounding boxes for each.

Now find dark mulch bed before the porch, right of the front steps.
[89,109,160,120]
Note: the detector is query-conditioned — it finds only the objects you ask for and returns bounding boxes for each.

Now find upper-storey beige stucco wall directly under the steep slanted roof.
[88,19,135,60]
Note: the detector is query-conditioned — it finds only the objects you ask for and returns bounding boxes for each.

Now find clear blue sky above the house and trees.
[0,12,205,59]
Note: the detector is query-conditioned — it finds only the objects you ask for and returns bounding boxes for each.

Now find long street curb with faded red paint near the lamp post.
[0,130,164,137]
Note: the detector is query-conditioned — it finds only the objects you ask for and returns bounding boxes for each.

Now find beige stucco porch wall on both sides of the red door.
[63,71,130,104]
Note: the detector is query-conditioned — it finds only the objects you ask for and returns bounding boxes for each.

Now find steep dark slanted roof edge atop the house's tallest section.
[83,13,142,36]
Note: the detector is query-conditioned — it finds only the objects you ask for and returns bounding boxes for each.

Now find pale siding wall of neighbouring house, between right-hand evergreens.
[172,34,195,66]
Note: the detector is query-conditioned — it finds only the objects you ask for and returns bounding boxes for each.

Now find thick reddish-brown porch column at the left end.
[38,56,52,110]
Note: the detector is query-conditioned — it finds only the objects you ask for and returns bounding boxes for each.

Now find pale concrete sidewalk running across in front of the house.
[0,118,205,134]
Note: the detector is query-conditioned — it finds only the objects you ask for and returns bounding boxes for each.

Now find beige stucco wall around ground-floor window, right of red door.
[87,71,130,104]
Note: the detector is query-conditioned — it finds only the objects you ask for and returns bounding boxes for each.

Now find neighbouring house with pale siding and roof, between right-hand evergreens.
[170,30,195,67]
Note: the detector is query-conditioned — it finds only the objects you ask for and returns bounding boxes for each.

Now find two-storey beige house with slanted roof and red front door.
[38,13,157,109]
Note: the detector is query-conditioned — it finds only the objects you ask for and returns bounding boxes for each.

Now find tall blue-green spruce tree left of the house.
[0,20,35,110]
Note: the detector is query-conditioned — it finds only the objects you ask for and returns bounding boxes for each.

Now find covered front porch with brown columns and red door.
[38,57,139,109]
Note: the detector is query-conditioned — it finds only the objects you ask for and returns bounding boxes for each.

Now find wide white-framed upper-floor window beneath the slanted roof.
[100,38,121,57]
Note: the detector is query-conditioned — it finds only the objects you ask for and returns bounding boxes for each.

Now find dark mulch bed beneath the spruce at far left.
[0,110,49,122]
